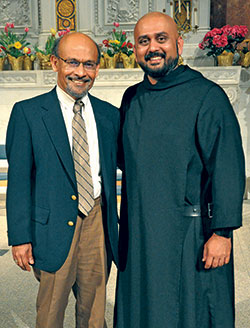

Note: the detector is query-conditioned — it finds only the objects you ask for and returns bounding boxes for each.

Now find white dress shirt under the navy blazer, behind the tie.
[56,85,101,198]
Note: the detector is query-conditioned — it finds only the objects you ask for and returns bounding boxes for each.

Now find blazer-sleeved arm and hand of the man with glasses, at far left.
[6,104,34,271]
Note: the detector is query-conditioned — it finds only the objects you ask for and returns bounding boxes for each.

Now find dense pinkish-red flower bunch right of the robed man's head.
[199,25,248,57]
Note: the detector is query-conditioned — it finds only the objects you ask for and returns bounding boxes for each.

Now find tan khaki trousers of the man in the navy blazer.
[34,198,107,328]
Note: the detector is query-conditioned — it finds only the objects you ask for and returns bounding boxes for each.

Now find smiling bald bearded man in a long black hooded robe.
[115,12,245,328]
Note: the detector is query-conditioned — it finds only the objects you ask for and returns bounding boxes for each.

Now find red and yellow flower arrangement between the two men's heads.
[102,22,133,57]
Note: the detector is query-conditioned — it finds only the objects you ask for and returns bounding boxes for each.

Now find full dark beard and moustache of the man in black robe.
[138,44,179,79]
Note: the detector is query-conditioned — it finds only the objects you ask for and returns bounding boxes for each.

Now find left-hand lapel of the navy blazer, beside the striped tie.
[42,88,77,190]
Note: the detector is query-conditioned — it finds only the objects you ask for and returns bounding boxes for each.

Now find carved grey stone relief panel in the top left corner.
[0,0,31,27]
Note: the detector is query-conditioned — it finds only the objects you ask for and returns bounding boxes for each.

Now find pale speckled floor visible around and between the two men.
[0,195,250,328]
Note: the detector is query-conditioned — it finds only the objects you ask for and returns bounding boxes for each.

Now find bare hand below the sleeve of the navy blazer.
[12,243,34,271]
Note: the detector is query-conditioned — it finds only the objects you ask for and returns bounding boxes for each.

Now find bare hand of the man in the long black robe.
[202,233,232,269]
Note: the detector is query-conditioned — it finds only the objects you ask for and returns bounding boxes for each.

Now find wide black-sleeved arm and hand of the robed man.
[198,86,245,269]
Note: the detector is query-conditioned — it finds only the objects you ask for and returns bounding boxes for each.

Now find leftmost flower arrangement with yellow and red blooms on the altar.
[0,23,30,58]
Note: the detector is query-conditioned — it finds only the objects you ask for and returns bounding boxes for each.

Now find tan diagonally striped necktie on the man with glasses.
[72,99,94,215]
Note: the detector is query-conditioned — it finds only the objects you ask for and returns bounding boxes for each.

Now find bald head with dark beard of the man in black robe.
[134,12,183,84]
